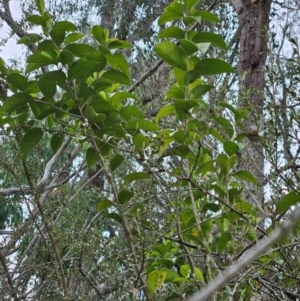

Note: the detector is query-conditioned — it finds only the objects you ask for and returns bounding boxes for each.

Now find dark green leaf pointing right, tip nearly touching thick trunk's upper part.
[195,59,235,75]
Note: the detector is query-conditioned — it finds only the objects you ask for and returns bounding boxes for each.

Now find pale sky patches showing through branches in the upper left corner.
[0,0,24,61]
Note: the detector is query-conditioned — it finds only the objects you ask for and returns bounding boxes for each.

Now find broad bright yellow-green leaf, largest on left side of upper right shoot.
[155,42,188,71]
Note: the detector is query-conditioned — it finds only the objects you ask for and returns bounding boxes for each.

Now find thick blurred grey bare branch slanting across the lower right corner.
[189,208,300,301]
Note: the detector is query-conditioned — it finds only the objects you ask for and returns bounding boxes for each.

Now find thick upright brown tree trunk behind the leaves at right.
[230,0,272,210]
